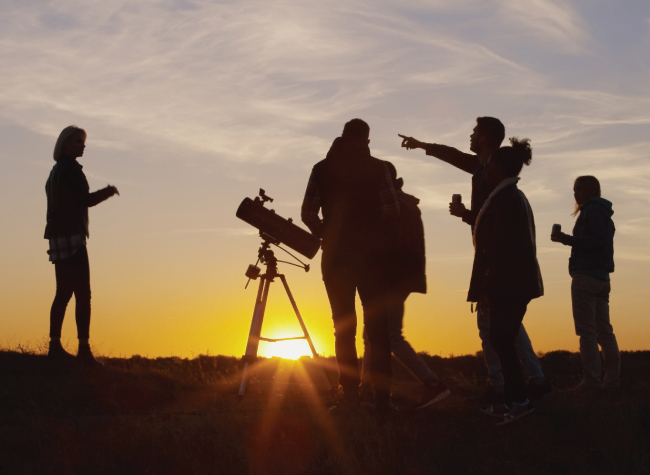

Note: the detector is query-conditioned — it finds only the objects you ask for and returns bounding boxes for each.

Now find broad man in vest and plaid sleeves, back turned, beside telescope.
[301,119,399,411]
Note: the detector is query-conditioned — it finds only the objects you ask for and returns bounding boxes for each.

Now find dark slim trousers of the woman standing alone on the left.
[50,246,90,339]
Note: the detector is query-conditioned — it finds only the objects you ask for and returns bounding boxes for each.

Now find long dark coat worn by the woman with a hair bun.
[467,179,544,302]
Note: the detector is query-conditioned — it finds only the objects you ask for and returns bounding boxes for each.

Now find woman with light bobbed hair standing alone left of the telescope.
[45,125,119,366]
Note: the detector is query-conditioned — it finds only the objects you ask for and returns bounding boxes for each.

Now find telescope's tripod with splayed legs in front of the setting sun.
[238,237,333,401]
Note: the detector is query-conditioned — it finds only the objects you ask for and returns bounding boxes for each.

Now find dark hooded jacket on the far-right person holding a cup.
[562,197,616,275]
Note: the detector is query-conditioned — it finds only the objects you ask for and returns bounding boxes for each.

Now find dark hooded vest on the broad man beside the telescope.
[311,137,394,269]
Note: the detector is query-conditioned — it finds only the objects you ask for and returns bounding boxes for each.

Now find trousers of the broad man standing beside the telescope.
[323,266,392,399]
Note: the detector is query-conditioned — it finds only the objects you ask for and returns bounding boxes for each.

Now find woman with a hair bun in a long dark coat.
[467,138,544,425]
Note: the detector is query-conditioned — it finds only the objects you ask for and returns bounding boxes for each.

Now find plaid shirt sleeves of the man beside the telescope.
[300,164,399,238]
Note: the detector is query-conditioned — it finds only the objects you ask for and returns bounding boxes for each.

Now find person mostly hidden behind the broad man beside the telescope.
[361,162,450,409]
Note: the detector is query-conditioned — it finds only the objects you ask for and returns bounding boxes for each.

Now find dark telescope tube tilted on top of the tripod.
[237,188,320,259]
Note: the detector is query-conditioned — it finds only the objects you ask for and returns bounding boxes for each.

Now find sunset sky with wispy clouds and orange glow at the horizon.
[0,0,650,357]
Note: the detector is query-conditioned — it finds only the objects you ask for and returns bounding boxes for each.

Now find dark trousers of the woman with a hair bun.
[488,295,530,404]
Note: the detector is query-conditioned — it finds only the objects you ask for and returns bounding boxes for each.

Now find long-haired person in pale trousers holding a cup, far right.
[551,176,621,390]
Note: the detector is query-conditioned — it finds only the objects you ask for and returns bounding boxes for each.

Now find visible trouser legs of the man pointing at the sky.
[476,306,544,389]
